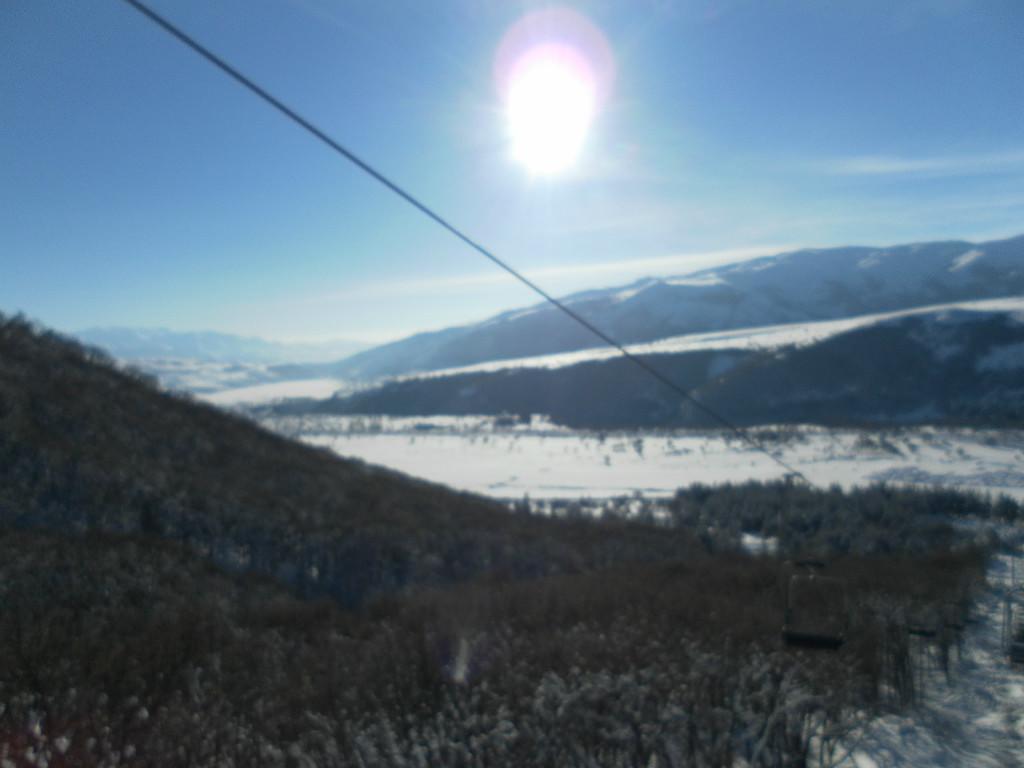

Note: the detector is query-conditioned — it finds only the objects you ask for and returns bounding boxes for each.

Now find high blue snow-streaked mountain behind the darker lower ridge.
[327,236,1024,380]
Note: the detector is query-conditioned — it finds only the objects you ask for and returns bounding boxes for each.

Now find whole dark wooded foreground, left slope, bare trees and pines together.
[0,321,1020,768]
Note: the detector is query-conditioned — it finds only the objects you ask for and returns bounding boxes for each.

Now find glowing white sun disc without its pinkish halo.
[505,44,597,175]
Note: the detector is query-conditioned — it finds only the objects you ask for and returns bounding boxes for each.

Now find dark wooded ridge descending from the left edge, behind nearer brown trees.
[0,317,688,605]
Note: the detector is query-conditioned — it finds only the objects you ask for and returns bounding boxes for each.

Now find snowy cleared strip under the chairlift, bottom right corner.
[837,555,1024,768]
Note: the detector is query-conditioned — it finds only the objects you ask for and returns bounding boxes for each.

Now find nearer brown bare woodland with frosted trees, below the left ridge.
[0,495,999,768]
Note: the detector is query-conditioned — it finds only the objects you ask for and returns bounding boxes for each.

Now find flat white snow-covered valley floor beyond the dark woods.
[264,416,1024,499]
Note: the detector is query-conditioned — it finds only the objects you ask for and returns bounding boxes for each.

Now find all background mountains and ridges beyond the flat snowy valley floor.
[79,236,1024,428]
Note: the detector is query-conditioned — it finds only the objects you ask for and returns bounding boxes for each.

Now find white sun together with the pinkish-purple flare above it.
[495,8,612,175]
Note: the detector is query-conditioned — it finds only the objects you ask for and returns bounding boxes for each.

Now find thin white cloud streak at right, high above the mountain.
[823,151,1024,176]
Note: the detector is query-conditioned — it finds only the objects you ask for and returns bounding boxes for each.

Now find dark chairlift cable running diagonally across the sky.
[116,0,813,485]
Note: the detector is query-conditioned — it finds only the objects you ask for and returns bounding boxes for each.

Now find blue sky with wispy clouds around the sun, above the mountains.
[0,0,1024,341]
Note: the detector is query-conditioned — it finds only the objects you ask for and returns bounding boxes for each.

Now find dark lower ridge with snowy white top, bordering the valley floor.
[286,299,1024,429]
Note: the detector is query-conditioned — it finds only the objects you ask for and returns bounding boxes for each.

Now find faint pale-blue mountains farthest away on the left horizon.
[76,328,369,365]
